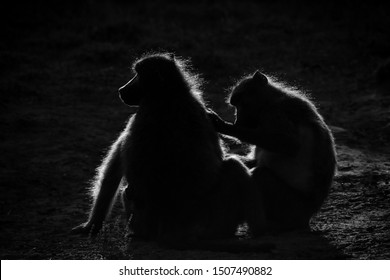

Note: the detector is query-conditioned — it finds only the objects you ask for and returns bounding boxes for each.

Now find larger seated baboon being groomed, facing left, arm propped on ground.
[74,53,251,247]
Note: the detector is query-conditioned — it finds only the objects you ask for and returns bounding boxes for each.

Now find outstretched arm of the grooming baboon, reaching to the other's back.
[219,122,299,155]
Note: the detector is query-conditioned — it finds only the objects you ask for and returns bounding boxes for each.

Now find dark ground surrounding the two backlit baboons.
[0,0,390,259]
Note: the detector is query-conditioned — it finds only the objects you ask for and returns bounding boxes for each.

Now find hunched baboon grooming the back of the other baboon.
[209,71,336,235]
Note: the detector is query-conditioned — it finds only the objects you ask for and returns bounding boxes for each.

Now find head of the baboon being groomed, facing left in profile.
[118,54,182,106]
